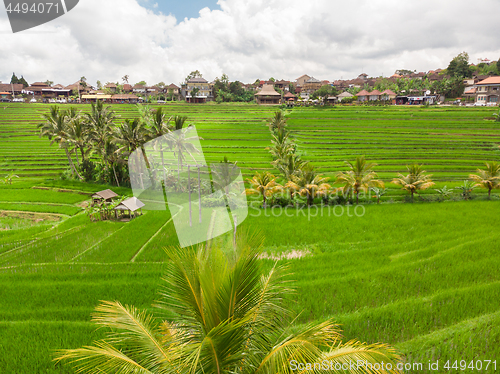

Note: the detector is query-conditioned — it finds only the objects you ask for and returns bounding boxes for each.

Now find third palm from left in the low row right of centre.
[337,156,384,204]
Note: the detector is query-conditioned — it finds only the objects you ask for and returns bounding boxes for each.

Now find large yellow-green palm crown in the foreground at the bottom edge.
[56,235,400,374]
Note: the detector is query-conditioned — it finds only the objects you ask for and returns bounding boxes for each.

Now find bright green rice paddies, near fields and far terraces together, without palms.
[0,104,500,374]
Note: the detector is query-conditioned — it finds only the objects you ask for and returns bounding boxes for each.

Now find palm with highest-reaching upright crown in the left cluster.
[86,100,116,155]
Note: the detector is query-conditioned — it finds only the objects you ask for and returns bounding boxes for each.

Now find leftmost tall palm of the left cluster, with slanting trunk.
[38,105,83,179]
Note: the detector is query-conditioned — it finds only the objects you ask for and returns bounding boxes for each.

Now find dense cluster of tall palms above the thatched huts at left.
[38,100,187,186]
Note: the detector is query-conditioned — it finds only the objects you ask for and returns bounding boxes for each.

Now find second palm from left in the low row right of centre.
[287,164,331,206]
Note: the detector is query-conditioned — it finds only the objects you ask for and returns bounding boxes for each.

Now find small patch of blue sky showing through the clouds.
[139,0,220,22]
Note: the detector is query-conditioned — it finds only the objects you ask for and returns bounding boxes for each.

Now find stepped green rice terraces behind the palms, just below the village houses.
[0,103,500,182]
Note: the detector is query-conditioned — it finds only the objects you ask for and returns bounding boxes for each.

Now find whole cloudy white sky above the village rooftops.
[0,0,500,85]
